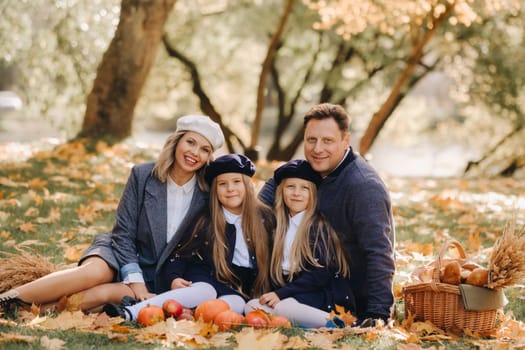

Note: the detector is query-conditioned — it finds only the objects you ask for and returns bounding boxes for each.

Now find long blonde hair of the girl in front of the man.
[270,181,349,286]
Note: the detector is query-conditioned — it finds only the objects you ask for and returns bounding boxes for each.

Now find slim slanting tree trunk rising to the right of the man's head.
[359,4,454,155]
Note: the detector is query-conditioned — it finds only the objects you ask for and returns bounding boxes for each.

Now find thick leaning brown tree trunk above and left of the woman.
[79,0,176,140]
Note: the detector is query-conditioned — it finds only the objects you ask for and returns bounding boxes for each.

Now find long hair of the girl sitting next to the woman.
[210,175,271,297]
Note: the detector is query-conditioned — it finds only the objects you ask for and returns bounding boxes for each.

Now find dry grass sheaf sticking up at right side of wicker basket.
[488,220,525,289]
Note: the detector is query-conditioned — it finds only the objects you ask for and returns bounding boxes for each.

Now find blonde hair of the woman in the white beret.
[153,130,213,191]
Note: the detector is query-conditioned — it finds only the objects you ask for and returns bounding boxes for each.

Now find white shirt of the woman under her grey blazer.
[166,175,197,242]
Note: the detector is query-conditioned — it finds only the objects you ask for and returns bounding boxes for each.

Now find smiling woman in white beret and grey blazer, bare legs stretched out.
[0,115,224,311]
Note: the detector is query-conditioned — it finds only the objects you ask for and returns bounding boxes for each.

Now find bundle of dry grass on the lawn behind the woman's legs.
[0,250,57,293]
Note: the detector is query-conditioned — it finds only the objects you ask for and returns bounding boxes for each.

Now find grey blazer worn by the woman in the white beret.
[81,163,209,293]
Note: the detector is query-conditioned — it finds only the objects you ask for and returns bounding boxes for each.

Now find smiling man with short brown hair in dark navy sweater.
[259,103,395,326]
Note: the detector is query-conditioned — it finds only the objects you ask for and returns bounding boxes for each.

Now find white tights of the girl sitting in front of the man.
[244,298,330,328]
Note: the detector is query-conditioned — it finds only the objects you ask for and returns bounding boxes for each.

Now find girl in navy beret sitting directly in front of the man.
[245,160,354,328]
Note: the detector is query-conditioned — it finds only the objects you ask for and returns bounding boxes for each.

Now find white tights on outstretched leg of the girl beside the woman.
[126,282,216,320]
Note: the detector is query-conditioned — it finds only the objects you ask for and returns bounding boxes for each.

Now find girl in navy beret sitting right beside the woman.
[104,154,275,320]
